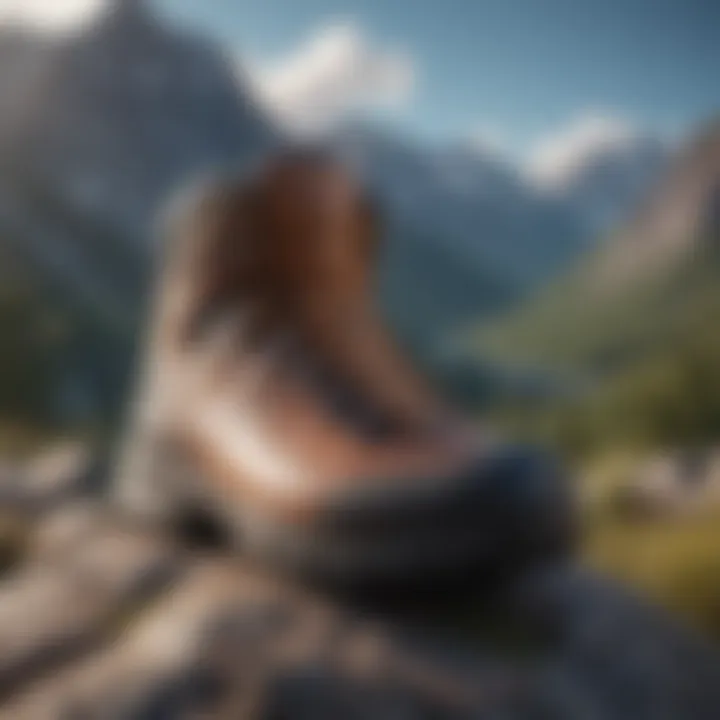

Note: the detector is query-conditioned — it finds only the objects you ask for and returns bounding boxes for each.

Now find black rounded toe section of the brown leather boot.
[296,447,575,583]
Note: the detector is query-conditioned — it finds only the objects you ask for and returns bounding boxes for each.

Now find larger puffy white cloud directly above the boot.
[250,22,415,132]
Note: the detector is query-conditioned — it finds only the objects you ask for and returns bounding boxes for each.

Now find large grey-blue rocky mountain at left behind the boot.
[0,0,277,317]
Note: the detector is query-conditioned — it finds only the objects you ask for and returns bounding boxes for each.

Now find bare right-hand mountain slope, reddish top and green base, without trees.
[464,123,720,371]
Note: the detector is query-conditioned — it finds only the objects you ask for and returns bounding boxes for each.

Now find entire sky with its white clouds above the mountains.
[0,0,720,173]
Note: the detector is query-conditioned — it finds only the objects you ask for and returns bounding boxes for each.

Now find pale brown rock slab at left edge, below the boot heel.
[0,512,181,695]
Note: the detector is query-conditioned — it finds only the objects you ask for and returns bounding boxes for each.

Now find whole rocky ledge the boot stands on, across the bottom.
[0,453,720,720]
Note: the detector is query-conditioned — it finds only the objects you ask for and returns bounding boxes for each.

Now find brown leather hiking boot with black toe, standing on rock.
[118,155,571,583]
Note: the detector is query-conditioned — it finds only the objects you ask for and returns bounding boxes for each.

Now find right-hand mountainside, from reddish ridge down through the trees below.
[460,123,720,460]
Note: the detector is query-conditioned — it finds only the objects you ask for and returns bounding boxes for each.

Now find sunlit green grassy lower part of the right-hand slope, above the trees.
[461,242,720,373]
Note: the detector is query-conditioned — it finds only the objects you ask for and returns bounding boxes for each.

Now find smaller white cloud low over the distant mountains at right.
[526,111,640,188]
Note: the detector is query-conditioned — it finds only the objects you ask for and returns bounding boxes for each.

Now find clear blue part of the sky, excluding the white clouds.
[159,0,720,152]
